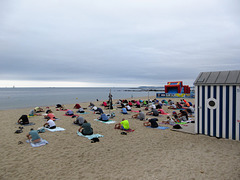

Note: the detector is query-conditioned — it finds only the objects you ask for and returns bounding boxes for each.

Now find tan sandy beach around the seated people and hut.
[0,97,240,180]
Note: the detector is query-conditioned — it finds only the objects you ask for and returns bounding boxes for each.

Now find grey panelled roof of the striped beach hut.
[194,70,240,85]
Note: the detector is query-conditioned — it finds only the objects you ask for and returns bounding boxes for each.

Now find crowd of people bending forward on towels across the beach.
[22,99,194,142]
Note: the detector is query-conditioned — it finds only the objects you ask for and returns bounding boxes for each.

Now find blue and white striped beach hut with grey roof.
[194,70,240,140]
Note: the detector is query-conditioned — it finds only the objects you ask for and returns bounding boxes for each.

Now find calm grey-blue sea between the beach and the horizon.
[0,87,156,110]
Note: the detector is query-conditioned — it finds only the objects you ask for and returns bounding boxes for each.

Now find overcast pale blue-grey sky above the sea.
[0,0,240,87]
